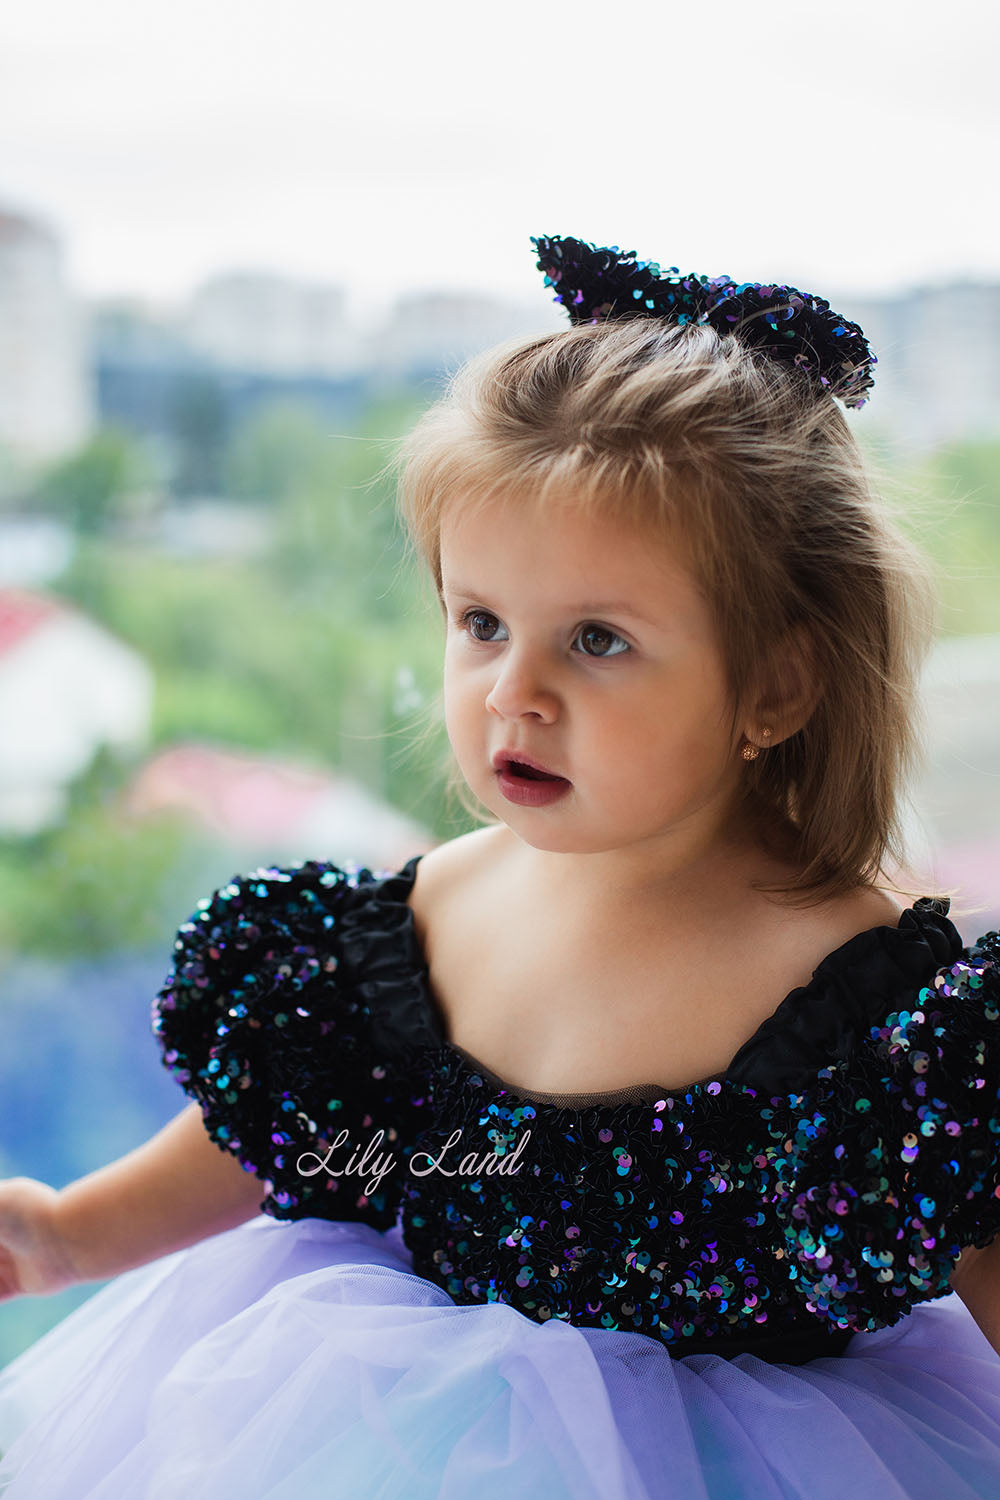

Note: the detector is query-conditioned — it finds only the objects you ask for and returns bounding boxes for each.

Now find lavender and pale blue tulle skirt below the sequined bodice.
[0,1215,1000,1500]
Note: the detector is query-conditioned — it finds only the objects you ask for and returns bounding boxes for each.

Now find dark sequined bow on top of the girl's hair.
[531,234,877,407]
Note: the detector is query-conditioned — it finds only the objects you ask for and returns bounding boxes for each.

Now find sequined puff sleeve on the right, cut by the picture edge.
[757,932,1000,1332]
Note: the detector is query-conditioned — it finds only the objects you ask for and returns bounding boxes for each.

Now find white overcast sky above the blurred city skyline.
[0,0,1000,315]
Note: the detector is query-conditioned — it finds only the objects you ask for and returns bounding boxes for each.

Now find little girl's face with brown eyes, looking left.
[441,501,744,867]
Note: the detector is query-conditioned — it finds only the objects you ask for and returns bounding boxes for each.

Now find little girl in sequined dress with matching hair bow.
[0,237,1000,1500]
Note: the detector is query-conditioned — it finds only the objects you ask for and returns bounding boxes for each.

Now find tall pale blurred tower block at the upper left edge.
[0,209,93,459]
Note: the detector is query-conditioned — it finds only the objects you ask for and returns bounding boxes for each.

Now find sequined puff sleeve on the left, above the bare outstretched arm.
[153,861,425,1230]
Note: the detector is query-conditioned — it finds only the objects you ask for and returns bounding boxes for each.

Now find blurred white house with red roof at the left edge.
[0,588,153,837]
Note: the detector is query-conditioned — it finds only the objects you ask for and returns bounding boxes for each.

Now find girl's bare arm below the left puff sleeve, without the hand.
[52,1101,267,1281]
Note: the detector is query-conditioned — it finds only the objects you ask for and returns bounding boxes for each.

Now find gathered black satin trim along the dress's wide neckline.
[339,855,964,1107]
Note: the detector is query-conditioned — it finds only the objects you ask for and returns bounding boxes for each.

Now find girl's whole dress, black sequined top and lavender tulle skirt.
[0,855,1000,1500]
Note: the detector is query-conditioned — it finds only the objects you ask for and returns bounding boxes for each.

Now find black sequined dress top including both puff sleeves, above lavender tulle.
[153,857,1000,1362]
